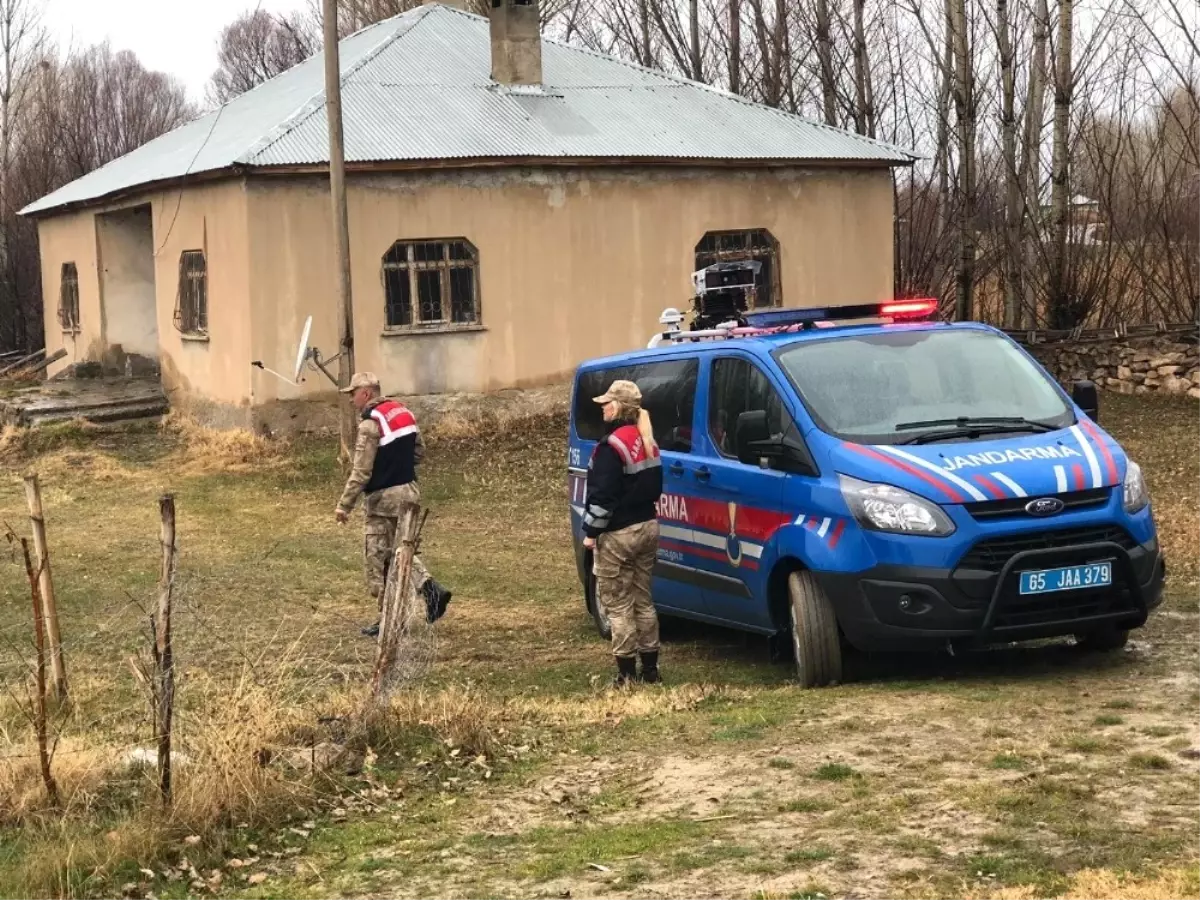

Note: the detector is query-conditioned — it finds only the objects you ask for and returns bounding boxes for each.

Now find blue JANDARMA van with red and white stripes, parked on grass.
[568,300,1165,686]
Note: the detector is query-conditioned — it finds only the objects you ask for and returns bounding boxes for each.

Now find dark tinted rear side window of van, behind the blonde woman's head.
[574,359,700,454]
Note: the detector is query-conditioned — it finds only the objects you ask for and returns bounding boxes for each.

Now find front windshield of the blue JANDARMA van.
[778,330,1075,444]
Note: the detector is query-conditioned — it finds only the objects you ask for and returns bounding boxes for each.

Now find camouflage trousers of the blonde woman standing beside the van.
[593,520,659,656]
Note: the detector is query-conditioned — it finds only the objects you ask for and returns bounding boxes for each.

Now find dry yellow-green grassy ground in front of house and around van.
[0,396,1200,900]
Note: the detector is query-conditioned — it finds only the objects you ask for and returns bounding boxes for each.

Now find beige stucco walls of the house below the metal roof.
[32,167,893,425]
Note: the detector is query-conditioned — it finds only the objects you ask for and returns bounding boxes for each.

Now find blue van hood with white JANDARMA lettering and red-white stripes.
[830,418,1126,504]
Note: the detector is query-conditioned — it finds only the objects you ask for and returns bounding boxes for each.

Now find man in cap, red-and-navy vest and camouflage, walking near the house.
[336,372,451,637]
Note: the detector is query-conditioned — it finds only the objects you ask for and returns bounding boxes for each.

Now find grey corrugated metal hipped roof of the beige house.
[22,6,913,214]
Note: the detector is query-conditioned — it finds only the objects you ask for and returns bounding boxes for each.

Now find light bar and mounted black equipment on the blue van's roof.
[648,296,938,348]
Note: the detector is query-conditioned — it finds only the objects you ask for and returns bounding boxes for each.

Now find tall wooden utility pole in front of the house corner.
[323,0,354,460]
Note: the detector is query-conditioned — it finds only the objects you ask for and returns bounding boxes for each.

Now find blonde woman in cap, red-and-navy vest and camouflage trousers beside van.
[583,382,662,686]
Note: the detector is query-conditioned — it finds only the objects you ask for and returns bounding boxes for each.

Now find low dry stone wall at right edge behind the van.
[1028,335,1200,400]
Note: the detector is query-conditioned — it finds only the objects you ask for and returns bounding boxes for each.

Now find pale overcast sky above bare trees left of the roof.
[43,0,305,101]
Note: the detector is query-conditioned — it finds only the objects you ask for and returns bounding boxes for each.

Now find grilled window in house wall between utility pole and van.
[383,238,479,329]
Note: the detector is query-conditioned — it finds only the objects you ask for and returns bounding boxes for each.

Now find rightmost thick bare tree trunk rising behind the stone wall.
[1050,0,1079,328]
